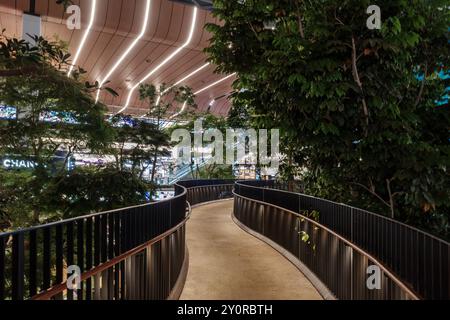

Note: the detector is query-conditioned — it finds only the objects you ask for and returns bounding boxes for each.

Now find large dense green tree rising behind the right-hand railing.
[206,0,450,238]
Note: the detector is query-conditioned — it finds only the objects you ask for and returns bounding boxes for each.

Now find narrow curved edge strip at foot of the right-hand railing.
[231,212,337,300]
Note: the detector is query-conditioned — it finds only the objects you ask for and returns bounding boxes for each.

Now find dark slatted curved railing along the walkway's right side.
[235,181,450,299]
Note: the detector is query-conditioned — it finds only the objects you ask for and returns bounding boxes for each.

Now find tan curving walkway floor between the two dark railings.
[181,200,321,300]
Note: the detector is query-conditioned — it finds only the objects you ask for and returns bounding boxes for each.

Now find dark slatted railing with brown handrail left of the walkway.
[0,186,189,300]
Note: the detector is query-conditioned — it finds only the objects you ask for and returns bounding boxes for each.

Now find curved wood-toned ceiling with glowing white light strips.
[0,0,234,115]
